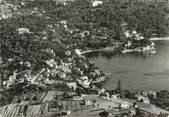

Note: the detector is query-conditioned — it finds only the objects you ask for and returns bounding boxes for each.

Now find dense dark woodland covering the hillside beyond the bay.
[54,0,169,39]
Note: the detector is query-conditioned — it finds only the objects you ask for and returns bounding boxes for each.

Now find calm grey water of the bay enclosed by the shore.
[87,41,169,91]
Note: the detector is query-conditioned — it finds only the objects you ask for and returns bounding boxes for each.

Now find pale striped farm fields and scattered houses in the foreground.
[0,81,169,117]
